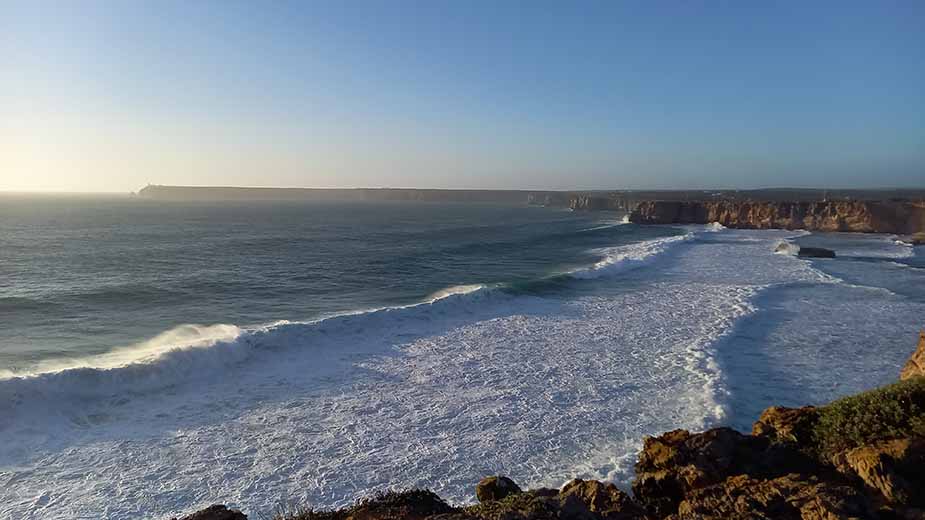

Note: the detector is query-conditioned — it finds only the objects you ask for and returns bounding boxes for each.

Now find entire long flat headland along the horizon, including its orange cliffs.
[138,185,925,234]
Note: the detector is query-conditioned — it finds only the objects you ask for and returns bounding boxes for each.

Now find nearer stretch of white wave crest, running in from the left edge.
[0,285,506,412]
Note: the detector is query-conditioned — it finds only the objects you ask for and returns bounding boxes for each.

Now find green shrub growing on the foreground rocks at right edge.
[813,377,925,456]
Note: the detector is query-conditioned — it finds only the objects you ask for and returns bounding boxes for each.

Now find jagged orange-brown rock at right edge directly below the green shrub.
[833,439,925,505]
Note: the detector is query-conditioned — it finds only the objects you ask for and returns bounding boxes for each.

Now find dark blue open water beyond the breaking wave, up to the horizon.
[0,196,674,370]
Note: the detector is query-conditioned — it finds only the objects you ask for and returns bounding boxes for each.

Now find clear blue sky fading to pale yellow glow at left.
[0,0,925,192]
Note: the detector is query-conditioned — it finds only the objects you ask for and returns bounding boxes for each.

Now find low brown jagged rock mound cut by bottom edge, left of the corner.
[668,474,872,520]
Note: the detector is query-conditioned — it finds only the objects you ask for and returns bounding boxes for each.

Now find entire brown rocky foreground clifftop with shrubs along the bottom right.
[175,332,925,520]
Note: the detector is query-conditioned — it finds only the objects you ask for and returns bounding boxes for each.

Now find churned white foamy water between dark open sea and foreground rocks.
[0,227,923,518]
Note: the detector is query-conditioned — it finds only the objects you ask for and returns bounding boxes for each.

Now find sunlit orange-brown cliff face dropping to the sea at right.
[630,201,925,234]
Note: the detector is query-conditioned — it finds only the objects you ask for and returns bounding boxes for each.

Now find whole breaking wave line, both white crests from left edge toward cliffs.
[0,236,694,418]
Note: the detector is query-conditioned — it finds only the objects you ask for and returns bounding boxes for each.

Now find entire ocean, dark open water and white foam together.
[0,196,925,519]
